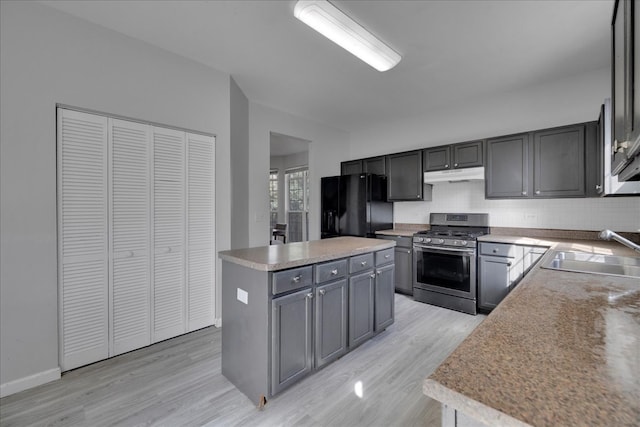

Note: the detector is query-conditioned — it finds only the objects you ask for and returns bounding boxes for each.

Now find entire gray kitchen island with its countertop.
[219,237,395,404]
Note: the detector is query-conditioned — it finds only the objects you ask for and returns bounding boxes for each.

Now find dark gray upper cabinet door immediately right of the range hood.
[485,133,529,199]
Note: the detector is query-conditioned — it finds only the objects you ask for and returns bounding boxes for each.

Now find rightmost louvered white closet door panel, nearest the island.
[187,133,215,331]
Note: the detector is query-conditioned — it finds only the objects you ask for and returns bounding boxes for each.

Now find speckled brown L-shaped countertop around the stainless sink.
[423,235,640,426]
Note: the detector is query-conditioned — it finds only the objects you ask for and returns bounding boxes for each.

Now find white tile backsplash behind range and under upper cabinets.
[393,181,640,233]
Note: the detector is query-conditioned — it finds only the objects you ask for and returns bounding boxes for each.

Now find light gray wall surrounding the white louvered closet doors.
[0,1,231,391]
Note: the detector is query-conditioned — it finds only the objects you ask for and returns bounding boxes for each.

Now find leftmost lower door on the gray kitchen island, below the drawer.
[271,288,313,394]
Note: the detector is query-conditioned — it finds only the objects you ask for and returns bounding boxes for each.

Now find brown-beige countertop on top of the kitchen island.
[218,237,396,271]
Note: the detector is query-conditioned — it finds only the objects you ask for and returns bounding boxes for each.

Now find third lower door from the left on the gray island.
[349,269,376,347]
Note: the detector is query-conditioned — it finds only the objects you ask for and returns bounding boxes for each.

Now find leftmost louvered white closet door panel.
[58,108,109,371]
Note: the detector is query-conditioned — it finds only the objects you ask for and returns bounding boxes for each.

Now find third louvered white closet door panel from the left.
[152,127,186,342]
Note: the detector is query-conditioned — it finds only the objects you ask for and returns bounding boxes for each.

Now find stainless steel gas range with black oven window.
[413,213,489,315]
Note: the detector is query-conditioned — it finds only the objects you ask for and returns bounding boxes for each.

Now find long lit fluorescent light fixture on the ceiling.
[293,0,402,71]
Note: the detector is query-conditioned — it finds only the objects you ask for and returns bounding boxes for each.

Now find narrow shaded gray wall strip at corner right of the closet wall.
[230,78,249,249]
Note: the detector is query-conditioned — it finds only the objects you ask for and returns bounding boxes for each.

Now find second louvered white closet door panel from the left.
[109,119,151,356]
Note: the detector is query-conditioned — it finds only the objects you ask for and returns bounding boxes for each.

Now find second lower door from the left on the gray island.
[315,279,348,368]
